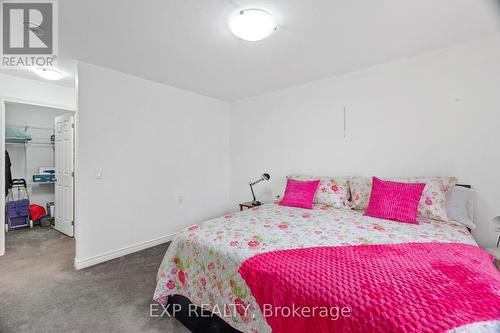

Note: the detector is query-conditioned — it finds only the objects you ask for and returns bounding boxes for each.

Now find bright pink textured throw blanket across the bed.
[239,243,500,333]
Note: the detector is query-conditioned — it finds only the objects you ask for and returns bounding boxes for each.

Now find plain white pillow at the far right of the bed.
[446,186,477,230]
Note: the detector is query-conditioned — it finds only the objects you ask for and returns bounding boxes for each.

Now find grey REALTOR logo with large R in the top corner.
[0,0,58,68]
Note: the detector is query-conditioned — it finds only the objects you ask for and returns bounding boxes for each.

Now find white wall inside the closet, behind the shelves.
[5,103,72,207]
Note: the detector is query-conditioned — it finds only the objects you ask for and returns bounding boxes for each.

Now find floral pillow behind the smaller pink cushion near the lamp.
[287,175,350,208]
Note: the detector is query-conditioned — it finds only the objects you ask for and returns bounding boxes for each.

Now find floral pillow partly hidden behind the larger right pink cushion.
[349,177,457,221]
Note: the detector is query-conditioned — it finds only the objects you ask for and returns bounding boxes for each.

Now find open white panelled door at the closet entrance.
[55,115,75,237]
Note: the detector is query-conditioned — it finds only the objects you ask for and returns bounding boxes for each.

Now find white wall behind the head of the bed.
[230,35,500,245]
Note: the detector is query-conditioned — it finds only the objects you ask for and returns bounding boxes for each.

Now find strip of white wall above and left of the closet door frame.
[0,74,76,255]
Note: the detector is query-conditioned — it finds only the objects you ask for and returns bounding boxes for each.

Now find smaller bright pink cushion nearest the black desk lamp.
[279,179,319,209]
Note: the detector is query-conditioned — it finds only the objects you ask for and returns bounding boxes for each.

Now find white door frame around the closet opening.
[0,96,79,258]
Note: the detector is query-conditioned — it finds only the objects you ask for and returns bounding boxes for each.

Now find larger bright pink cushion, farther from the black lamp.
[365,177,425,224]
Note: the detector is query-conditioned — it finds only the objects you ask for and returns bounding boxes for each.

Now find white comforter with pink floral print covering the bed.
[154,204,498,332]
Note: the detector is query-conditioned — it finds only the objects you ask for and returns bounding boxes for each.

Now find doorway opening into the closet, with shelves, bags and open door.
[5,102,75,244]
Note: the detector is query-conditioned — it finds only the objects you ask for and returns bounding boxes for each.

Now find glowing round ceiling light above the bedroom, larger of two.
[229,9,278,42]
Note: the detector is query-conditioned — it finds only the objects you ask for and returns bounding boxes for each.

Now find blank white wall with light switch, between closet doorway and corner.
[76,63,229,267]
